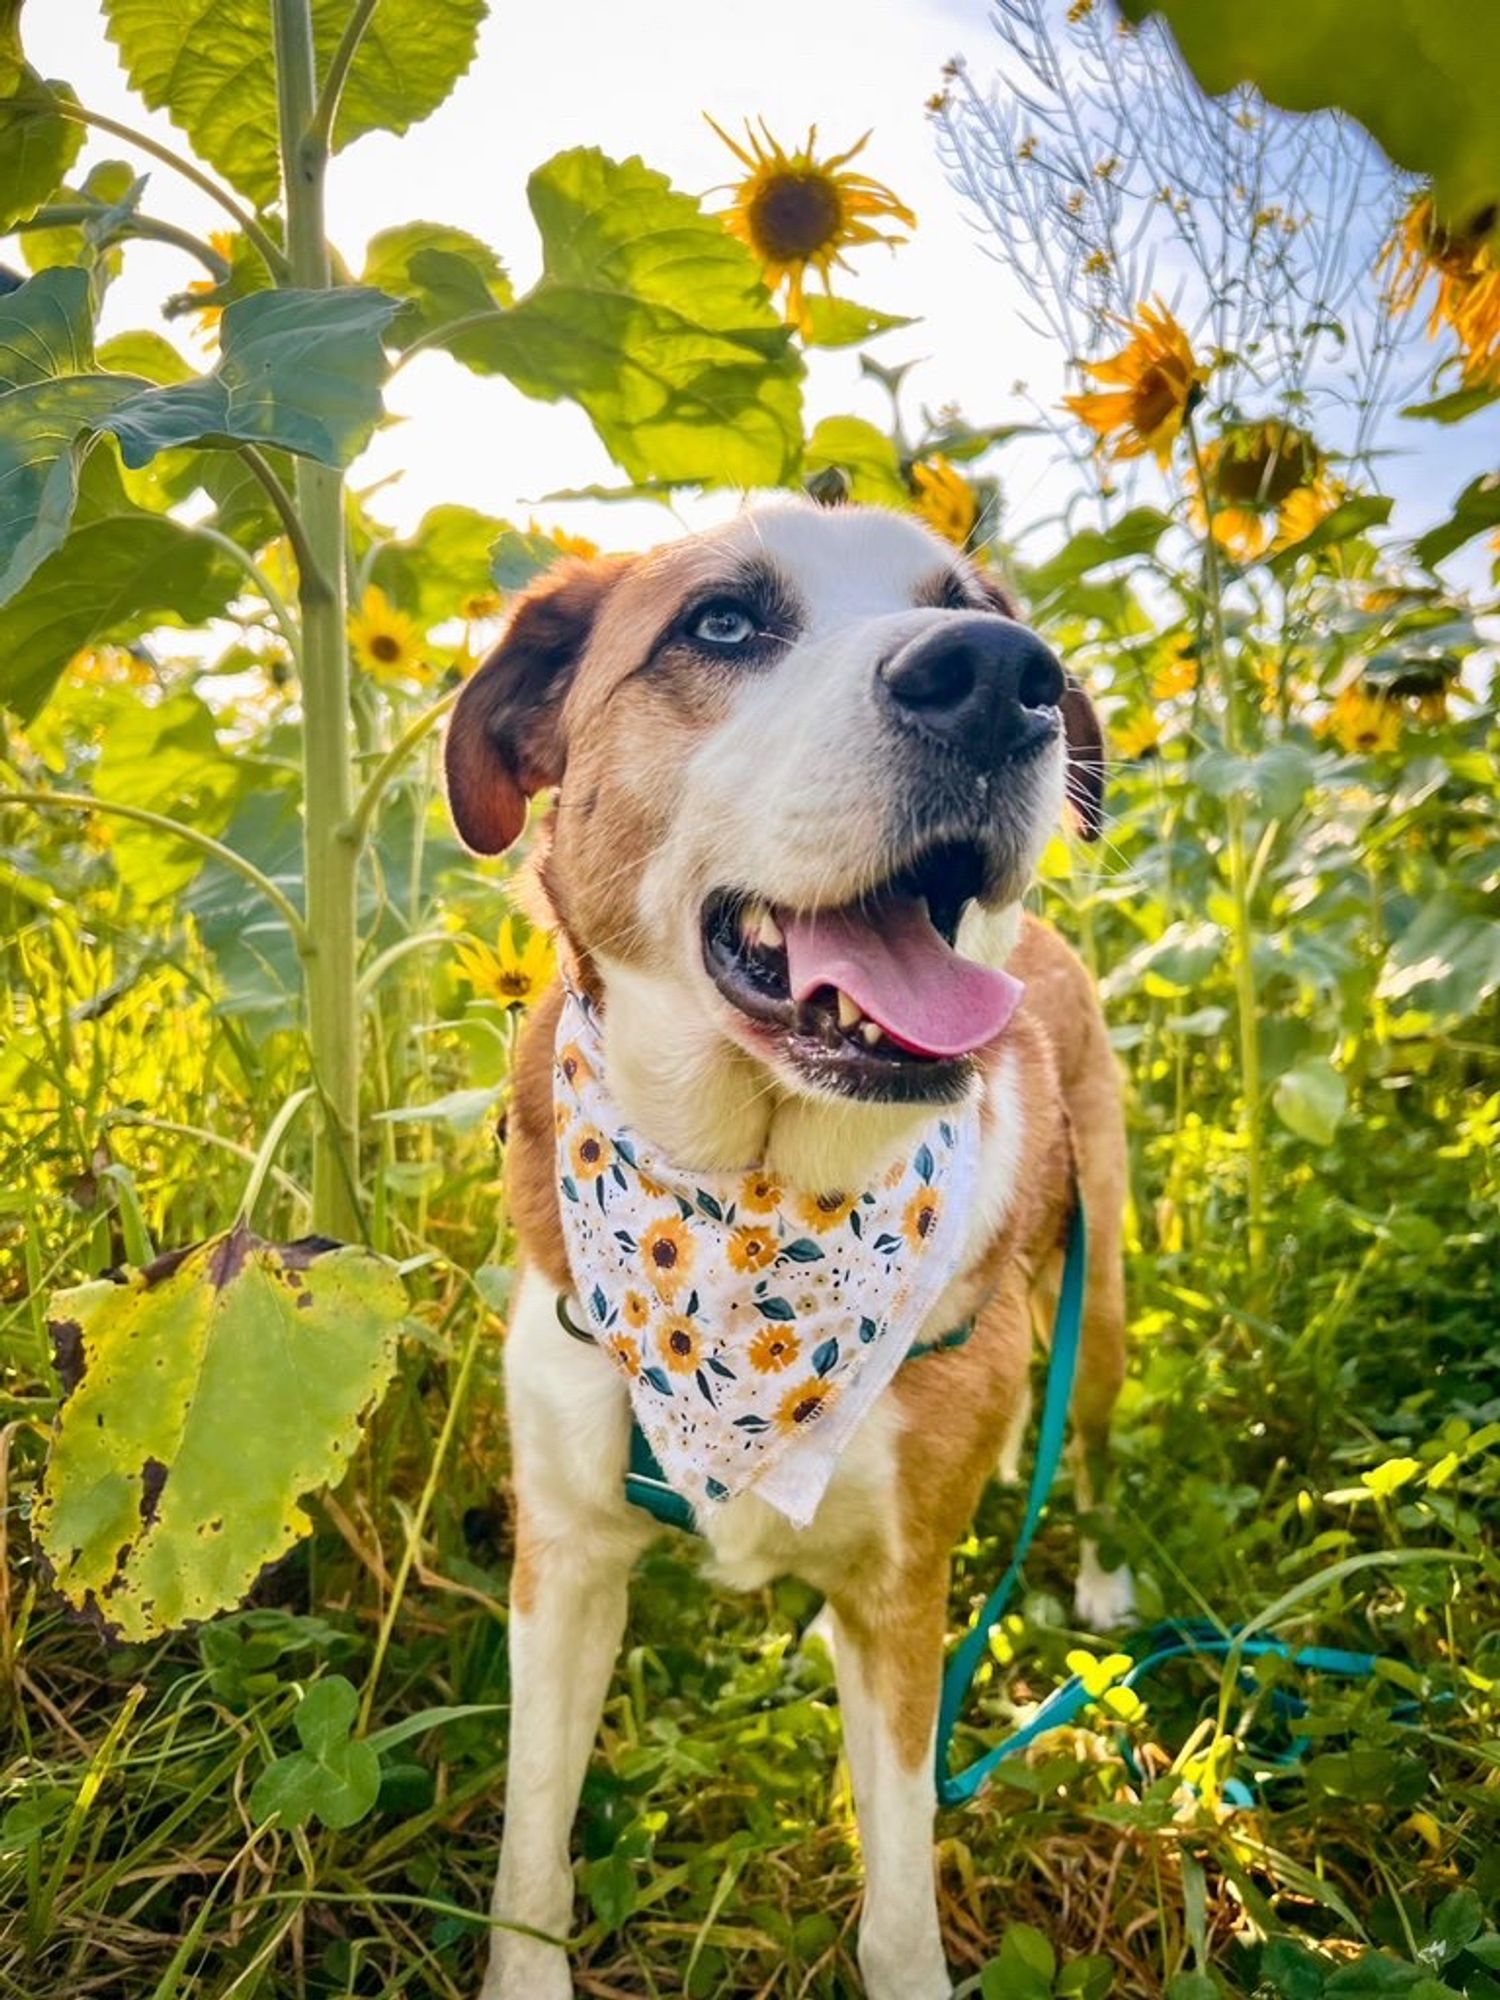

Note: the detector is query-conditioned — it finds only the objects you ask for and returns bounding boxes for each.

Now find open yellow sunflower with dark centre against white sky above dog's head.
[708,118,916,334]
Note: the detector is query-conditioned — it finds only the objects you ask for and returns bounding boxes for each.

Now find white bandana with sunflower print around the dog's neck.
[552,990,978,1528]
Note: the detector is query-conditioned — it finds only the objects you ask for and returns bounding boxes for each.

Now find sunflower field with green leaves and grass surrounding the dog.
[0,0,1500,2000]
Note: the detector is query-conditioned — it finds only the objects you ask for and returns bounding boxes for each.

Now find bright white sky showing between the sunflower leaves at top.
[10,0,1500,584]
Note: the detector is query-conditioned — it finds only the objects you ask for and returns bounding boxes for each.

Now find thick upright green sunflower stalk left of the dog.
[272,0,360,1240]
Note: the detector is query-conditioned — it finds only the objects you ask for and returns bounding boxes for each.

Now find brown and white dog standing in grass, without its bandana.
[448,502,1130,2000]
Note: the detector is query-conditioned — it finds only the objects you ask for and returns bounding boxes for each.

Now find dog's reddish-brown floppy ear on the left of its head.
[444,556,626,854]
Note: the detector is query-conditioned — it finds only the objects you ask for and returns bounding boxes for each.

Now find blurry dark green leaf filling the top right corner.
[1122,0,1500,226]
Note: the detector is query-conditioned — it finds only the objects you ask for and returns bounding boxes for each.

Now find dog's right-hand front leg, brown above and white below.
[832,1576,952,2000]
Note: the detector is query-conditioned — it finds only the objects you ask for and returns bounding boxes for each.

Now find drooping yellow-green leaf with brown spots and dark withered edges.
[34,1222,406,1640]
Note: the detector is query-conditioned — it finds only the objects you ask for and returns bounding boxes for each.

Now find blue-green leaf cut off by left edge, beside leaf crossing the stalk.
[0,270,146,604]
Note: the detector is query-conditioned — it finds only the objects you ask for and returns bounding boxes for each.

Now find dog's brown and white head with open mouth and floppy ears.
[448,504,1102,1166]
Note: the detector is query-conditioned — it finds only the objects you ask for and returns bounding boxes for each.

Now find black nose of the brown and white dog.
[878,612,1064,764]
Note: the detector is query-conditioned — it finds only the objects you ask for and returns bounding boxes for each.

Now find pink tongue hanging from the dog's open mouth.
[776,896,1024,1056]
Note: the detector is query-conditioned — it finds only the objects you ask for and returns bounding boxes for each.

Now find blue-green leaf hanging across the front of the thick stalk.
[104,286,398,466]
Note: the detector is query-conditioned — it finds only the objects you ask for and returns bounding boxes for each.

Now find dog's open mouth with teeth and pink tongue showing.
[702,842,1020,1104]
